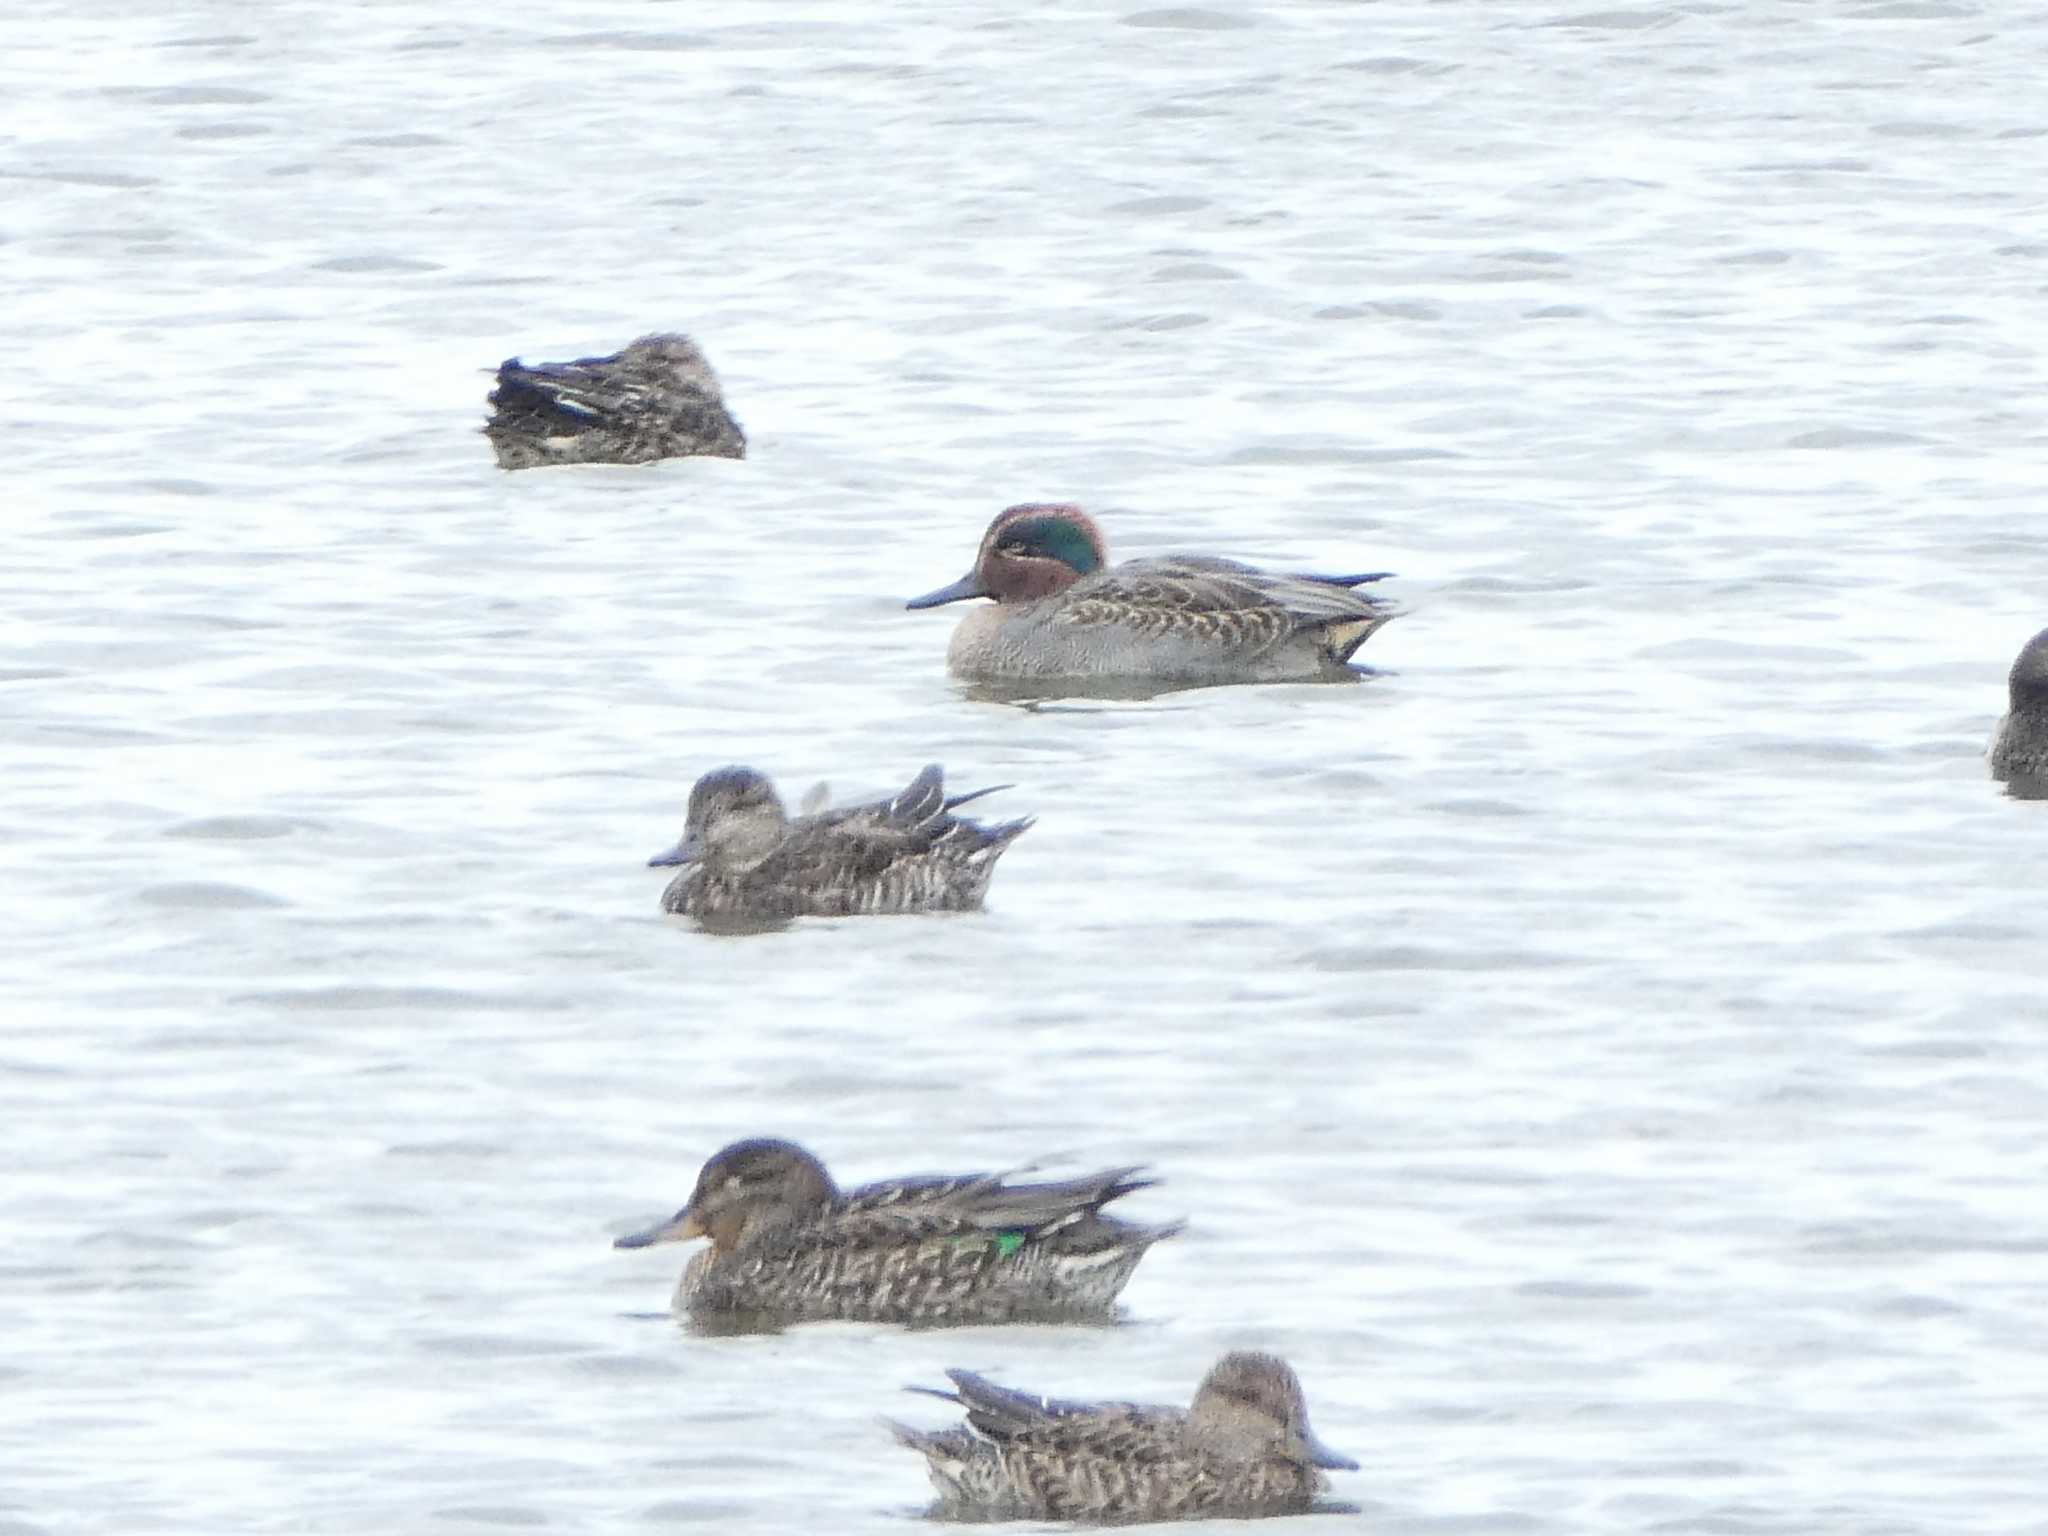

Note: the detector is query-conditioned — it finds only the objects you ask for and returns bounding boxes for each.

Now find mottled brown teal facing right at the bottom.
[889,1352,1358,1522]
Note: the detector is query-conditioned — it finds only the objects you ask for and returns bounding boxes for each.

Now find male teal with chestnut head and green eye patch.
[905,504,1395,684]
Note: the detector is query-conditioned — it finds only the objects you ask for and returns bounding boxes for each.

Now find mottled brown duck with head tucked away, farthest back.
[483,334,748,469]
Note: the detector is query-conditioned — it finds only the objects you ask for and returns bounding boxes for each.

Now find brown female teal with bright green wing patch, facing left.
[614,1139,1180,1327]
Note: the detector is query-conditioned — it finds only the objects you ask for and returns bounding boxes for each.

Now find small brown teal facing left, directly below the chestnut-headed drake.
[647,762,1032,922]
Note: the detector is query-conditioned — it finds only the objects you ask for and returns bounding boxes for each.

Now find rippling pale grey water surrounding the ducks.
[0,0,2048,1536]
